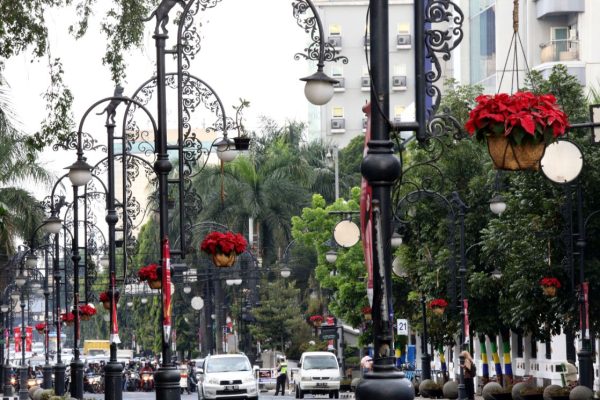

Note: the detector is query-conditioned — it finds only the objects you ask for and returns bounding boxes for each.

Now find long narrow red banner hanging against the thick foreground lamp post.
[360,103,373,306]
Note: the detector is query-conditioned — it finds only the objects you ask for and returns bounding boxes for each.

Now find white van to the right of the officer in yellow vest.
[294,351,341,399]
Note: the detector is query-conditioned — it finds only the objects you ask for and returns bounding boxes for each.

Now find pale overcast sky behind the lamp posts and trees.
[5,0,312,177]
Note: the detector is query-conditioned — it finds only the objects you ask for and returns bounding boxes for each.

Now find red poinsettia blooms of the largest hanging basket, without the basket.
[465,92,569,144]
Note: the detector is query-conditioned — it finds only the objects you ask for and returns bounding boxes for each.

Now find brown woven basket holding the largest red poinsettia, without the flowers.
[487,136,546,171]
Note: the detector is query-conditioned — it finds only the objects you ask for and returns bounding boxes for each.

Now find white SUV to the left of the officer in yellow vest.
[198,354,258,400]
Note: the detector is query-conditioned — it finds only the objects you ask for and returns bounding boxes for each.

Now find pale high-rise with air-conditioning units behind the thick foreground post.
[309,0,415,148]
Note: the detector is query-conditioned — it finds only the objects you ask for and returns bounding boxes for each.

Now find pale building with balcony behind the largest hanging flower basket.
[455,0,600,93]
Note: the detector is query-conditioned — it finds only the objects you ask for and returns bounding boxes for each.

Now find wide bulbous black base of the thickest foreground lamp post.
[355,357,415,400]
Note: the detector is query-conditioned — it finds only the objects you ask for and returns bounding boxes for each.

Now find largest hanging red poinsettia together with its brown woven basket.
[465,91,569,171]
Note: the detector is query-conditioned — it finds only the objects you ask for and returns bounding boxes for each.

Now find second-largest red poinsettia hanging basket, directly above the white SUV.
[200,231,248,268]
